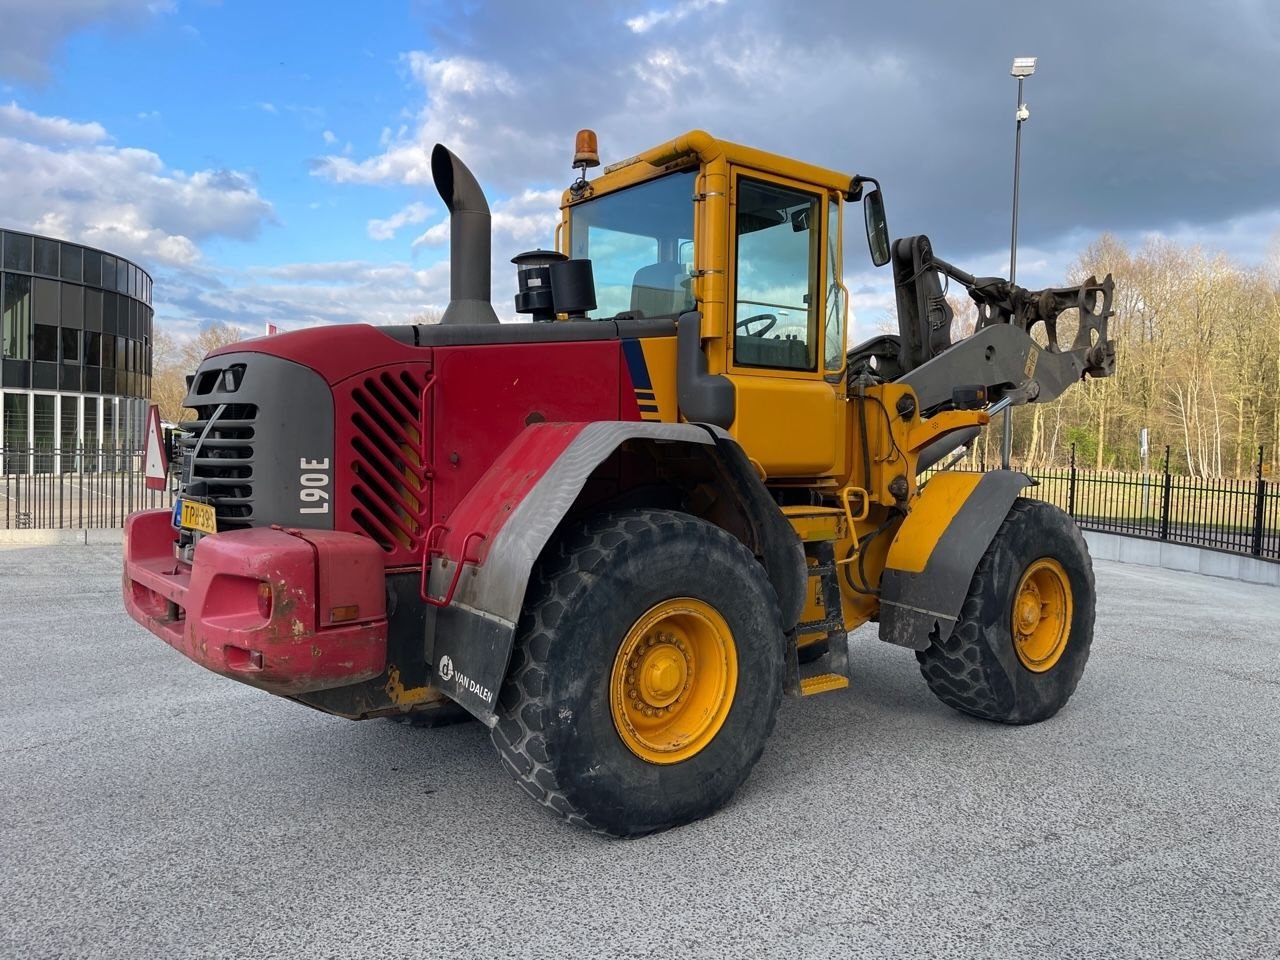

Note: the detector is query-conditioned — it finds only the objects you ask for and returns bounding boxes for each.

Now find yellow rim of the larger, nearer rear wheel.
[609,596,737,763]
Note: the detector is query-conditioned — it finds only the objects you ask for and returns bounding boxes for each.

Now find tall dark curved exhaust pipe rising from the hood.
[431,143,498,324]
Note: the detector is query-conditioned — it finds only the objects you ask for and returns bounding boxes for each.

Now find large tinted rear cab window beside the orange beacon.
[568,170,695,317]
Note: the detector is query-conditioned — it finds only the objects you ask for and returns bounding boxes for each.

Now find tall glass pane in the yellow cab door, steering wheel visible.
[733,178,822,370]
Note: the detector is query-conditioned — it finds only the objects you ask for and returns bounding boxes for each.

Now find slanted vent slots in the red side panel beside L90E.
[351,369,430,553]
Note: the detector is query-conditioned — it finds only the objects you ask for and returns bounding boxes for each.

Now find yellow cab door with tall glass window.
[726,169,846,479]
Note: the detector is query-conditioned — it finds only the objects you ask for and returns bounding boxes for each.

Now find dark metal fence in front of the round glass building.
[0,447,173,530]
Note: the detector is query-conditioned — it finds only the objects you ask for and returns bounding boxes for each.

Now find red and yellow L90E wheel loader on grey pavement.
[123,131,1115,837]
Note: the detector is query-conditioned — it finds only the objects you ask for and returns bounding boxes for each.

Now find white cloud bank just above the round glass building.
[0,104,274,264]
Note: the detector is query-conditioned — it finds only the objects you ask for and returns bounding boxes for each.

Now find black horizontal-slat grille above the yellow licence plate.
[180,403,257,530]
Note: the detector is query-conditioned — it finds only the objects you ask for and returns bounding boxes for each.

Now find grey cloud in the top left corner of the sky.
[0,0,173,83]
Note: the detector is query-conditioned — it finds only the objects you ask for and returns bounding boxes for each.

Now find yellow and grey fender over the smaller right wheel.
[879,470,1033,650]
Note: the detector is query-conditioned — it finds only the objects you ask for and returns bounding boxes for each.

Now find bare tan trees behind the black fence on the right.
[952,236,1280,477]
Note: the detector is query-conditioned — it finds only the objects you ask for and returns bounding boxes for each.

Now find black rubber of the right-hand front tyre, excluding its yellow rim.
[915,498,1094,723]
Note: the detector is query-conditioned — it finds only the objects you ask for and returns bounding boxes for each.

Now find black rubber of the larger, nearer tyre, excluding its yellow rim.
[492,509,786,837]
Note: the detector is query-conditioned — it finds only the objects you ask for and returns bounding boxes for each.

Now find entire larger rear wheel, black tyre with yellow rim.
[492,509,786,837]
